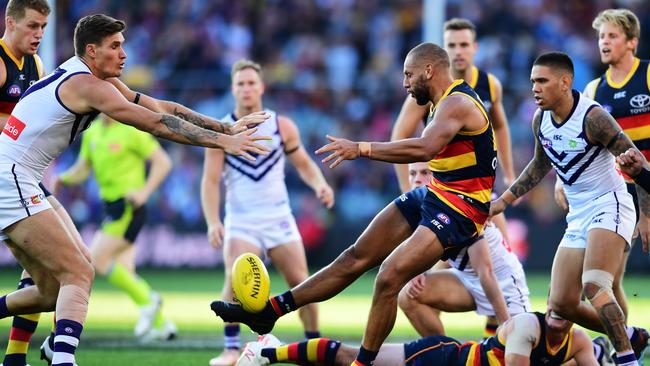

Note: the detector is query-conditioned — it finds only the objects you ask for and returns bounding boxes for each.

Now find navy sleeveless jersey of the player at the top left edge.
[0,40,41,117]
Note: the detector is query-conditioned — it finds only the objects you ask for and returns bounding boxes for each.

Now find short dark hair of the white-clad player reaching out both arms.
[74,14,126,56]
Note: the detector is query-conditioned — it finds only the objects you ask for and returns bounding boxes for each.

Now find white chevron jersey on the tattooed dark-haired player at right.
[537,90,625,207]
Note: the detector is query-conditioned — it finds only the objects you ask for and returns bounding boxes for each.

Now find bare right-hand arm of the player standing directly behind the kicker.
[491,77,515,185]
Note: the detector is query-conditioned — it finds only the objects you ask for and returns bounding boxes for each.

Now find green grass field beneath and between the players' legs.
[0,269,650,366]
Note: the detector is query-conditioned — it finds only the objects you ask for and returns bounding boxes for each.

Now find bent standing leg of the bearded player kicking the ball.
[355,226,444,365]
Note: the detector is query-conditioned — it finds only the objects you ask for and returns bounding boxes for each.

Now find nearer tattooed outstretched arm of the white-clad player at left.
[71,75,269,160]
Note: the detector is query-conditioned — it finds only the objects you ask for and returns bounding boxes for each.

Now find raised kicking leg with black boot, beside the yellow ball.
[211,203,412,334]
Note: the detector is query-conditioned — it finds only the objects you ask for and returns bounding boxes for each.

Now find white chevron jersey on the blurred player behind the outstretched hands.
[222,110,291,220]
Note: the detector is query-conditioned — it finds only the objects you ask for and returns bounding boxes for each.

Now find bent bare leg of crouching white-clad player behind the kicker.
[398,269,476,337]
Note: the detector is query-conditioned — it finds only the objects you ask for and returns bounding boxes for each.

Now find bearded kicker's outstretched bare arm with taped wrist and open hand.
[316,94,478,168]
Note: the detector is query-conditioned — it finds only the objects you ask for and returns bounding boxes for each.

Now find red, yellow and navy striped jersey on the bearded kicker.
[427,80,497,232]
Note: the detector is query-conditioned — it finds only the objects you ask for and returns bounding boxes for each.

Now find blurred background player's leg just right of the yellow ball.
[268,241,320,338]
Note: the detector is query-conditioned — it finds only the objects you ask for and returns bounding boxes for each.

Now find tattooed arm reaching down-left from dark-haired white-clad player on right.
[510,111,551,198]
